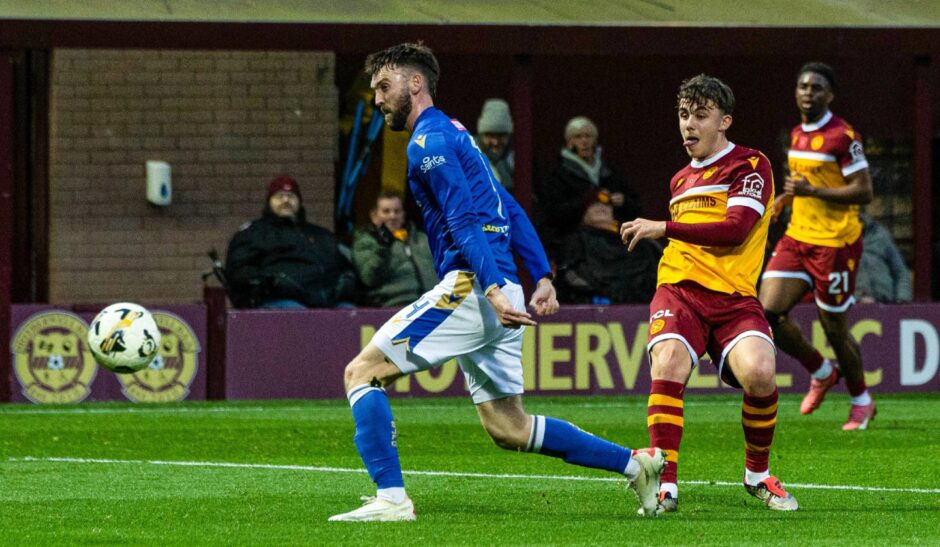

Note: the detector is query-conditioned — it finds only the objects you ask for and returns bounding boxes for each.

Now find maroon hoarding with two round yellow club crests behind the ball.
[9,304,206,403]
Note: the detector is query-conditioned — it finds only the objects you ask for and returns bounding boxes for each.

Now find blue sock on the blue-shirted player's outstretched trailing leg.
[526,416,633,474]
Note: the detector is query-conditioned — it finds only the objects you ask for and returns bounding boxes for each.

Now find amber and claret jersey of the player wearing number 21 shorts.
[787,112,868,247]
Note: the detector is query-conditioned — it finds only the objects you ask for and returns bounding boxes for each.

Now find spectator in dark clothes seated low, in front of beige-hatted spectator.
[557,191,663,304]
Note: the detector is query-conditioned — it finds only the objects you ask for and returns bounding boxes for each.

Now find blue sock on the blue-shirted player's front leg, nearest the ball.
[346,384,405,490]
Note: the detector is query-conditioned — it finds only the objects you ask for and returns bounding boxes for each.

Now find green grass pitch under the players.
[0,394,940,545]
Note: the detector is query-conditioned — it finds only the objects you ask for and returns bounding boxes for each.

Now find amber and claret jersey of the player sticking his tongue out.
[657,142,774,296]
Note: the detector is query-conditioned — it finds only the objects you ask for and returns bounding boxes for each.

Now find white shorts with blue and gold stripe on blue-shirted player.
[372,271,525,403]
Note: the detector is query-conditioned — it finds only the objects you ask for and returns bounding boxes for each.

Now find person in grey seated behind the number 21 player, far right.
[855,213,912,303]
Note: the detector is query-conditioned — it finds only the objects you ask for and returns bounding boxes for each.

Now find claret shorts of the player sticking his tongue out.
[646,283,774,388]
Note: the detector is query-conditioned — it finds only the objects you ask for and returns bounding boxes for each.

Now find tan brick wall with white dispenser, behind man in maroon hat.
[49,49,338,304]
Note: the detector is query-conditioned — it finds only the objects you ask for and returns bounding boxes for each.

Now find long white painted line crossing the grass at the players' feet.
[7,456,940,494]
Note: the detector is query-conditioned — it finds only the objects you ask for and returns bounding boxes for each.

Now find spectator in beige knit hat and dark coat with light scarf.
[535,116,640,257]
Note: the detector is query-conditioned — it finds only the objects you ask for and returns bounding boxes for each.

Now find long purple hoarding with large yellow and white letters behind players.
[225,304,940,399]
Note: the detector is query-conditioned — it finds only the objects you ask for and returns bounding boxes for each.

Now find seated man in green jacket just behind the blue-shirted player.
[352,192,439,307]
